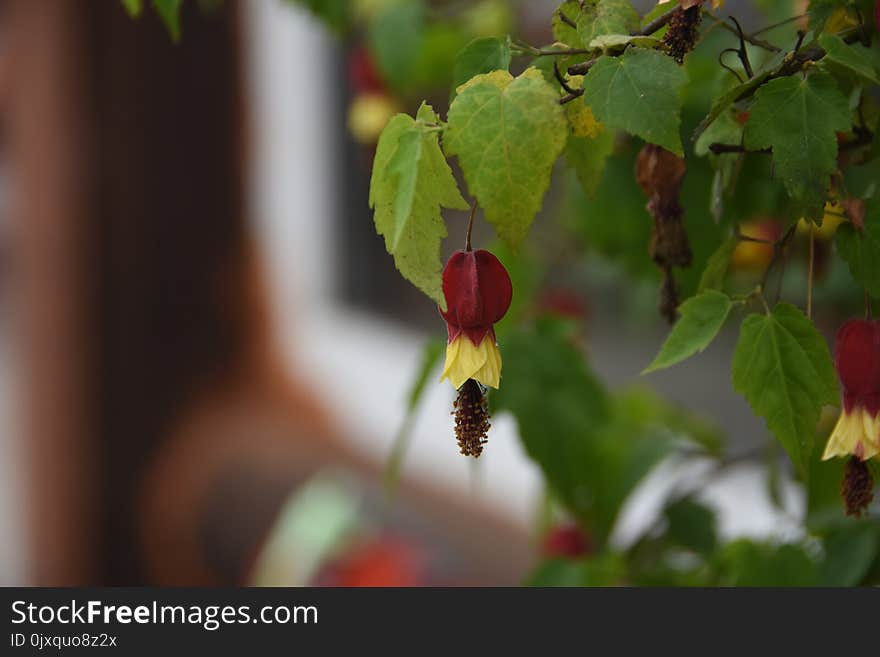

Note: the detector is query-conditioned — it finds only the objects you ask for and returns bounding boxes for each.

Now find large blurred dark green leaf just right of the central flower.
[491,318,688,546]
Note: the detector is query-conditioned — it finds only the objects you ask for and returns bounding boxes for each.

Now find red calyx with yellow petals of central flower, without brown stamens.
[440,250,513,389]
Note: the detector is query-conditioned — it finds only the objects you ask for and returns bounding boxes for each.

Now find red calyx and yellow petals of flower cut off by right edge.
[822,319,880,461]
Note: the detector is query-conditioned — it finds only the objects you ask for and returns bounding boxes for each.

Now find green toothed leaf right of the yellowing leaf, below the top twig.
[584,48,687,155]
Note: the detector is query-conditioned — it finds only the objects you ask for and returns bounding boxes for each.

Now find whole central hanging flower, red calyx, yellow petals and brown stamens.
[440,249,513,457]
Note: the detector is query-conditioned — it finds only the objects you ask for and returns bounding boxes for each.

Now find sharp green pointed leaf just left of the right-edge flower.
[733,303,838,473]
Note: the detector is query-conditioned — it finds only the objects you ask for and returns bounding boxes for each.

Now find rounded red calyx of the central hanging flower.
[442,249,513,335]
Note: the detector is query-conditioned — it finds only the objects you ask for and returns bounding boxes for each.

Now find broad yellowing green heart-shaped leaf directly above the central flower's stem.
[443,68,568,248]
